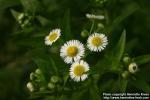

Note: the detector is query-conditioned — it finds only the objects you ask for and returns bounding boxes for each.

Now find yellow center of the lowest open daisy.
[73,65,85,76]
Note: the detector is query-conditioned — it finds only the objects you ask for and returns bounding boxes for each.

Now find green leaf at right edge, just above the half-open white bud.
[133,54,150,65]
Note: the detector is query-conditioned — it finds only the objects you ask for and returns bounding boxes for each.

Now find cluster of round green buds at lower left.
[27,69,61,92]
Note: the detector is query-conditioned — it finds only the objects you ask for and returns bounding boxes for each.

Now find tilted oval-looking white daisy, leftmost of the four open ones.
[45,29,61,45]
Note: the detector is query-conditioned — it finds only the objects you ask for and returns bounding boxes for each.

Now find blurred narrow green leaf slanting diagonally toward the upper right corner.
[104,2,139,34]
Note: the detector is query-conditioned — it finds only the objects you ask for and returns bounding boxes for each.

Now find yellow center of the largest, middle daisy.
[67,46,78,57]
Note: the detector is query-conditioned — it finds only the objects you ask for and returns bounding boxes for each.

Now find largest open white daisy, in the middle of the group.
[60,40,84,64]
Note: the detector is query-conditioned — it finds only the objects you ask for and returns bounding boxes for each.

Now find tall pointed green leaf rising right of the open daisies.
[91,30,126,73]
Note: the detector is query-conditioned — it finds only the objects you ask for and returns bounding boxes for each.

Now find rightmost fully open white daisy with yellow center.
[87,33,108,52]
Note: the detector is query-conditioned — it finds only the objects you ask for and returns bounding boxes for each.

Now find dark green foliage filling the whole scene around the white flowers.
[0,0,150,100]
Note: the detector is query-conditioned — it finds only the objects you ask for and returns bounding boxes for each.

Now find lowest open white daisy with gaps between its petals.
[70,60,89,82]
